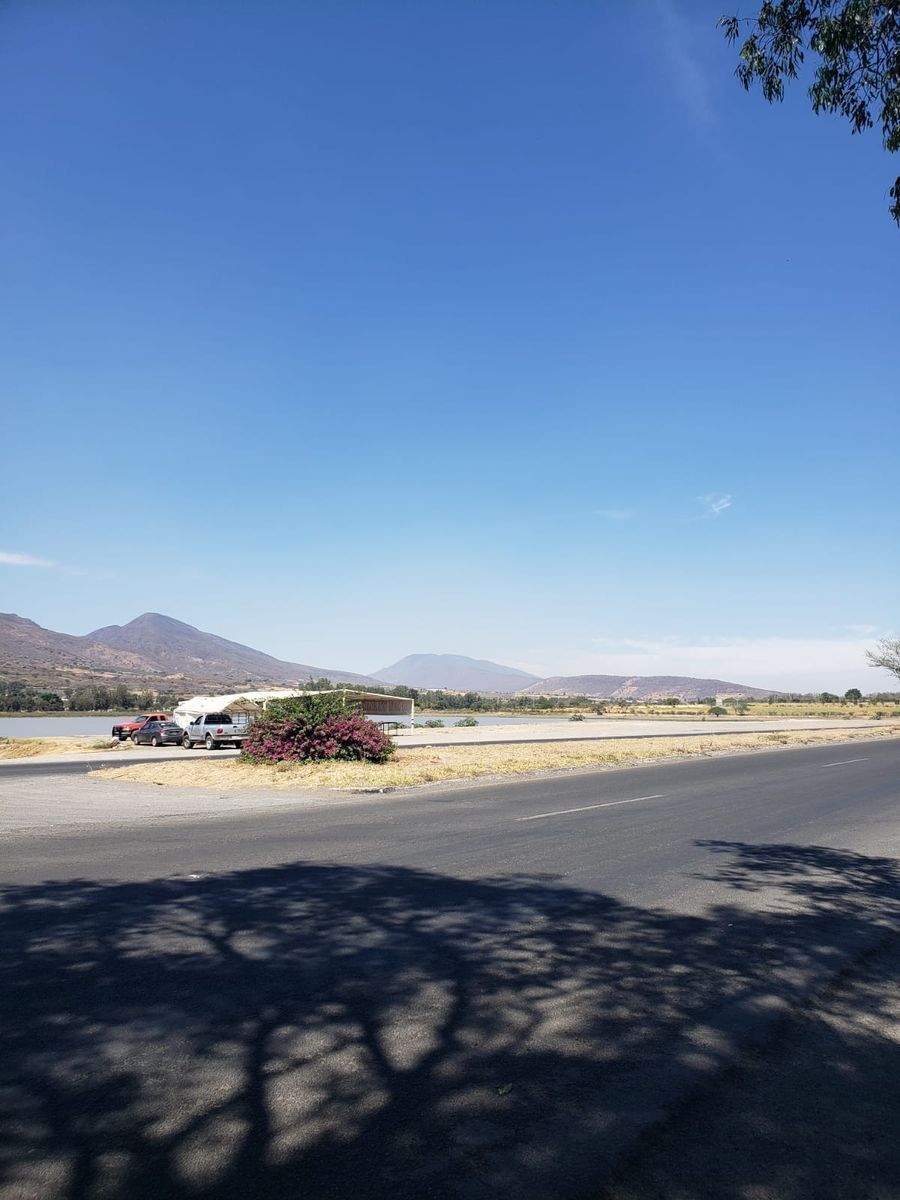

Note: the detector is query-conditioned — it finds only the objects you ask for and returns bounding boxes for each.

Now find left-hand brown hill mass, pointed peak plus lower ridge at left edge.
[0,612,376,691]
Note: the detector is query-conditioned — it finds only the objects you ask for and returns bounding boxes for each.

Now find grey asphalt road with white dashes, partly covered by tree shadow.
[0,742,900,1200]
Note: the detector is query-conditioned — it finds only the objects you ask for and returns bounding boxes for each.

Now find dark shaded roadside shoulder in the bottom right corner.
[602,935,900,1200]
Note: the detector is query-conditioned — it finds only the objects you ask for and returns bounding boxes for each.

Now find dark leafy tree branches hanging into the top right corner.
[719,0,900,224]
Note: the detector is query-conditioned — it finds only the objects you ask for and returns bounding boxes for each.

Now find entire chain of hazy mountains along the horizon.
[0,612,772,700]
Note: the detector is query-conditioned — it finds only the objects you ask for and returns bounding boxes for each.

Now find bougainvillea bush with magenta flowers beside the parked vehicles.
[244,696,394,762]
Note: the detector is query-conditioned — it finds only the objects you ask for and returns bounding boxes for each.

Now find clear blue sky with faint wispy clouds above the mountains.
[0,0,900,689]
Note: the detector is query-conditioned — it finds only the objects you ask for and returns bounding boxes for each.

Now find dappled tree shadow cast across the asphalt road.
[0,844,900,1200]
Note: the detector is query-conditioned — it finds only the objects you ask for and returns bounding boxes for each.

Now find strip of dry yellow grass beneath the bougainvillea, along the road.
[94,725,900,791]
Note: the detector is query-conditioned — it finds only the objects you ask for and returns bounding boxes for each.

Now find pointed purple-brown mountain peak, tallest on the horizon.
[86,612,376,684]
